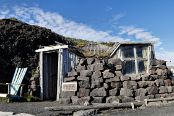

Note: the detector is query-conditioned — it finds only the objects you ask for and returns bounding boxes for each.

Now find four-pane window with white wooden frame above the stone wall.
[121,45,149,74]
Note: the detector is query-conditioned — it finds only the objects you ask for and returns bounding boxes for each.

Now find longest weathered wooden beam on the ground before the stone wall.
[45,102,144,111]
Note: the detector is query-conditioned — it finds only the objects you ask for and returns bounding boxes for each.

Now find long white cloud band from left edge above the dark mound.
[0,6,127,42]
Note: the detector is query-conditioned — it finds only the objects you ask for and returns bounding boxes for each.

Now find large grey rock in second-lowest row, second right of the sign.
[90,87,106,97]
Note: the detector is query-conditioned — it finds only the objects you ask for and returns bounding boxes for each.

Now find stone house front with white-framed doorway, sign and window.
[36,43,174,104]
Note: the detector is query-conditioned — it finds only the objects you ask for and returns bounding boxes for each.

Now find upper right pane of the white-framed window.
[136,46,148,59]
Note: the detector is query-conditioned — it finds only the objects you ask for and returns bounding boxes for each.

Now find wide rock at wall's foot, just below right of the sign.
[71,96,91,105]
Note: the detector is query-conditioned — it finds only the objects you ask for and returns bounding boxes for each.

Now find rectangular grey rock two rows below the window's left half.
[123,81,137,89]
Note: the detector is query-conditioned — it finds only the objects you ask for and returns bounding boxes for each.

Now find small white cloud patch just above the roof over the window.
[119,26,161,46]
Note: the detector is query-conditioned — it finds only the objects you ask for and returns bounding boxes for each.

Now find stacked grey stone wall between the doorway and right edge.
[60,58,174,104]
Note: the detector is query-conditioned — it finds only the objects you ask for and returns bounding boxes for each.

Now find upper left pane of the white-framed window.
[122,46,134,58]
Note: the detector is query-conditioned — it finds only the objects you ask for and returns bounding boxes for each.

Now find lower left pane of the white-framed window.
[123,61,135,74]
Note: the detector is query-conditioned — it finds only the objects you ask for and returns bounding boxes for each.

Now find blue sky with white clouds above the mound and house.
[0,0,174,65]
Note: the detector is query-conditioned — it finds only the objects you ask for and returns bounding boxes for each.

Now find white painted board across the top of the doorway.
[35,45,68,52]
